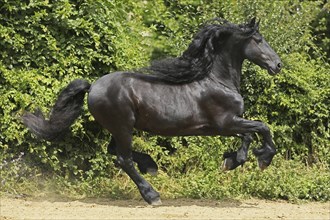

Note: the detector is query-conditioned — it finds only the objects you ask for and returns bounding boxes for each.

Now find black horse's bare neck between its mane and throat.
[212,55,243,92]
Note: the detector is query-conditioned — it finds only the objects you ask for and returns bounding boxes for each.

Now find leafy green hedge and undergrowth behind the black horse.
[0,0,330,200]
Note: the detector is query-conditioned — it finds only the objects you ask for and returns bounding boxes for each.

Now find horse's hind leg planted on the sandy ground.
[113,132,161,205]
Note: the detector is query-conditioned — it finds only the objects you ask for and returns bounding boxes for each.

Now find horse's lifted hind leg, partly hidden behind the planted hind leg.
[108,138,158,176]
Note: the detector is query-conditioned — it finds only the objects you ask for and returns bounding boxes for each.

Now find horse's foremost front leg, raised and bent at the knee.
[224,116,276,170]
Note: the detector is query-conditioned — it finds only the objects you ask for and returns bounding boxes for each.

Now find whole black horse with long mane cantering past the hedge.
[23,18,282,205]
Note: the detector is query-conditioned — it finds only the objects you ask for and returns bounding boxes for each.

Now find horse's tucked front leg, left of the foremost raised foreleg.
[223,134,253,170]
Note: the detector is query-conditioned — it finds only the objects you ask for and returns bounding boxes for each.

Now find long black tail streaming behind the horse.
[22,79,91,141]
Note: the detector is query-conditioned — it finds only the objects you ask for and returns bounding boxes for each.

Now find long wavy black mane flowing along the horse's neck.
[146,18,257,84]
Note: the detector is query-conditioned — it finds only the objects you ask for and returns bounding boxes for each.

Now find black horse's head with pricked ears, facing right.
[243,18,282,75]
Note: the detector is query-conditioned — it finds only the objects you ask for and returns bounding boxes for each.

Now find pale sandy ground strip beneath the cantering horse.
[0,198,330,220]
